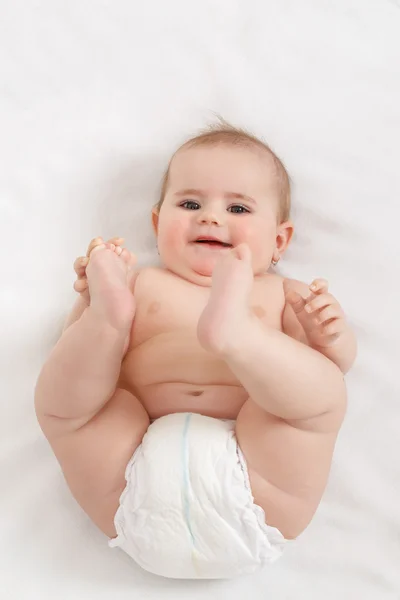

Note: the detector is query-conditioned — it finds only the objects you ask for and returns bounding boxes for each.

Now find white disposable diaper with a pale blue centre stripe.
[109,413,286,579]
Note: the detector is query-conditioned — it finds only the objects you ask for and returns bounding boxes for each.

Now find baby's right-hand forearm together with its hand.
[282,279,357,373]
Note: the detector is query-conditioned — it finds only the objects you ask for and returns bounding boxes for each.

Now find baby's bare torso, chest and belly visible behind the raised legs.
[120,270,283,408]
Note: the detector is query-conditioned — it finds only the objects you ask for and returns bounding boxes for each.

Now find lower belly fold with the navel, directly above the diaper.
[139,382,247,419]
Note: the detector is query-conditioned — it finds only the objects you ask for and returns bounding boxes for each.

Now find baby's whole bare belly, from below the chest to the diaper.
[119,331,247,419]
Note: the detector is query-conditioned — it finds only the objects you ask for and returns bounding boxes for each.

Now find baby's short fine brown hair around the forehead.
[156,117,291,223]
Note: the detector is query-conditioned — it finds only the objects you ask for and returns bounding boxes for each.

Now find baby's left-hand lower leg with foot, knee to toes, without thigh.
[35,249,133,429]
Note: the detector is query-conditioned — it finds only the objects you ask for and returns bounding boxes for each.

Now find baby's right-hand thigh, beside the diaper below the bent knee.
[236,399,337,539]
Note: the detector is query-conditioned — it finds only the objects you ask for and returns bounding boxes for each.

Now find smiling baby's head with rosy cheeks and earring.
[153,123,293,285]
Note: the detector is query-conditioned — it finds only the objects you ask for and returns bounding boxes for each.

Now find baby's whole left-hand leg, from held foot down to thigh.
[35,250,149,536]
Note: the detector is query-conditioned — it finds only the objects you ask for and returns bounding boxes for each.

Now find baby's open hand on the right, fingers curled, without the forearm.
[283,279,347,349]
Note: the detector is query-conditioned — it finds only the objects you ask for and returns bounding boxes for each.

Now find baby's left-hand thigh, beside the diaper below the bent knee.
[49,389,149,537]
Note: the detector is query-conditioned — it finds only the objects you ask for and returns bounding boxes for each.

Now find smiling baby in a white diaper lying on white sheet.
[35,124,356,577]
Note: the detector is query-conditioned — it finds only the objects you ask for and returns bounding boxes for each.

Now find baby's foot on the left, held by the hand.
[86,243,135,330]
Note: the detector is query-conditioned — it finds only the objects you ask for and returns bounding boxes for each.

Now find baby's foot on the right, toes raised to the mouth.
[197,244,253,355]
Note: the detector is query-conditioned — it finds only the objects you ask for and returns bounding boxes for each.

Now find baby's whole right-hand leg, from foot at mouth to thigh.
[199,246,346,538]
